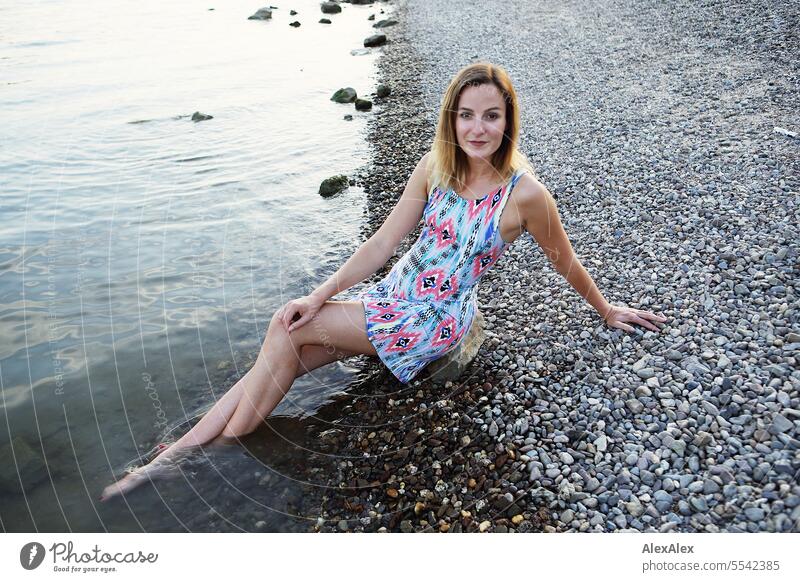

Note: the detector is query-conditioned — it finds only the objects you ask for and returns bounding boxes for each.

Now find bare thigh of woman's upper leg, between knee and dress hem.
[289,301,377,356]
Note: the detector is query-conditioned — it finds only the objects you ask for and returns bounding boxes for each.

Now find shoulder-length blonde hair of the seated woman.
[428,62,537,192]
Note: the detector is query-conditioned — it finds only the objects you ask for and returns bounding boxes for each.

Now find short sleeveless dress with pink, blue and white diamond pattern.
[354,169,526,384]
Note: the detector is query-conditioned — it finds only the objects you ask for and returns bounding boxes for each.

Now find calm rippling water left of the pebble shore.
[0,0,384,531]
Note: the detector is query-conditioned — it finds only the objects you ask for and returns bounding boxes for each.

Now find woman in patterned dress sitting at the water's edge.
[101,63,666,500]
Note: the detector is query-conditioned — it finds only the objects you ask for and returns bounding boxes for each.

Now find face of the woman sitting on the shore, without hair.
[456,83,506,161]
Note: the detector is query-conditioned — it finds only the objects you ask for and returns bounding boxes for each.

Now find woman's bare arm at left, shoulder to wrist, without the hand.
[310,154,430,302]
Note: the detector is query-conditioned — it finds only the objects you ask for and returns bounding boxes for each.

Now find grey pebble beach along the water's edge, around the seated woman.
[308,0,800,533]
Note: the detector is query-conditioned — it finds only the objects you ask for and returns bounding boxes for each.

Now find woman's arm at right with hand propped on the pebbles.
[515,174,667,331]
